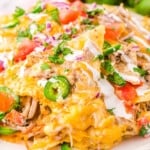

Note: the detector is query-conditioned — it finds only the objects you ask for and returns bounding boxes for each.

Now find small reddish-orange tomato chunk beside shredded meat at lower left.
[5,109,25,126]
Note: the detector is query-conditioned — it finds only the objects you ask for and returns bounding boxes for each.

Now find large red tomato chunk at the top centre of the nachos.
[59,0,86,24]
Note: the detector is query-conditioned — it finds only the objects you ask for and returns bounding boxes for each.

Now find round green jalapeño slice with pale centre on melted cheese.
[44,75,70,101]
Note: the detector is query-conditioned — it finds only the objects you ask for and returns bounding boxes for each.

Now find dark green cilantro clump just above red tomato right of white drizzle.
[107,72,126,86]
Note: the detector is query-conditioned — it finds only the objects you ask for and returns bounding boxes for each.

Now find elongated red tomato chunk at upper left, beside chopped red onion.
[14,40,37,62]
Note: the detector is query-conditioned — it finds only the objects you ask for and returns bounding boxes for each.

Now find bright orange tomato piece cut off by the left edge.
[0,92,14,112]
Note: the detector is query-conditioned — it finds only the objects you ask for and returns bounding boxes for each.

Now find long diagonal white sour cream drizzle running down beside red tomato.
[83,62,132,119]
